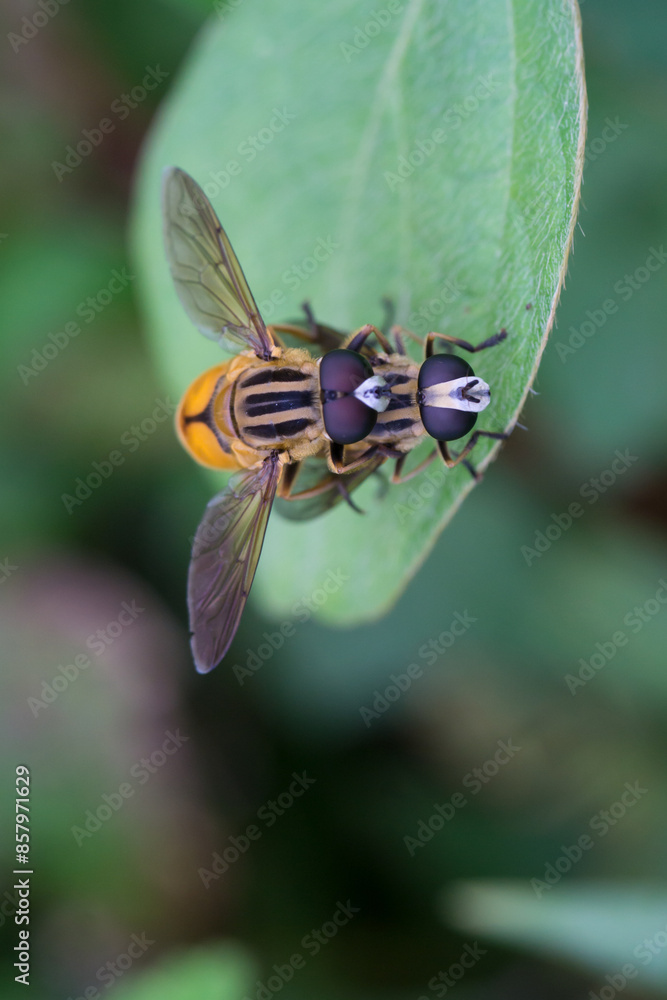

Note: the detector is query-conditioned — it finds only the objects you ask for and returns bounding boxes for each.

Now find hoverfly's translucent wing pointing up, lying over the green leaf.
[162,167,274,358]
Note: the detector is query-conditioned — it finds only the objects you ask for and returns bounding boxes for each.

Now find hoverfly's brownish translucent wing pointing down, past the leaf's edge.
[188,452,281,674]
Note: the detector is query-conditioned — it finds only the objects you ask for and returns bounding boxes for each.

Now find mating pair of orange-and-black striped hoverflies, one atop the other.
[162,167,506,673]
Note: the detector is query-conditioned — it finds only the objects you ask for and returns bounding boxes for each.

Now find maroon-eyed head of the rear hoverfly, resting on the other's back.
[320,348,389,444]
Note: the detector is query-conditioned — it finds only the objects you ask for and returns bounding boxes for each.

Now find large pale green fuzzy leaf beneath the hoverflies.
[134,0,586,624]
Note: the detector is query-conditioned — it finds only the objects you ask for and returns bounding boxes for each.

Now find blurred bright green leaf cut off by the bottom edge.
[116,943,257,1000]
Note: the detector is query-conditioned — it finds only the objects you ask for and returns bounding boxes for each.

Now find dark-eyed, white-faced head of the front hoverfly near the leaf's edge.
[417,354,491,441]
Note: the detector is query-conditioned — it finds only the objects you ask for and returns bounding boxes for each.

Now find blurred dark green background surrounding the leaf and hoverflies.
[0,0,667,1000]
